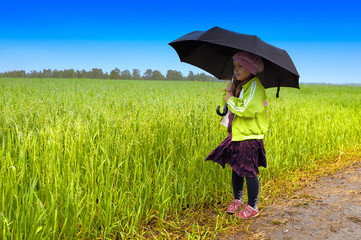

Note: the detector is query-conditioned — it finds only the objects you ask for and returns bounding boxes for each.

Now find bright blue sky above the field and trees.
[0,0,361,83]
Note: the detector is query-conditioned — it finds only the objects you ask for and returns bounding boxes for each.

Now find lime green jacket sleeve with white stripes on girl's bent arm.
[227,81,265,118]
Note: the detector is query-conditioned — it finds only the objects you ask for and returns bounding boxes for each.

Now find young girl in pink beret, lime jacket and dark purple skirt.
[206,51,268,219]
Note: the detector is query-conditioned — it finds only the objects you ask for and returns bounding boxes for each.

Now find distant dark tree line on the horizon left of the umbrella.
[0,68,217,81]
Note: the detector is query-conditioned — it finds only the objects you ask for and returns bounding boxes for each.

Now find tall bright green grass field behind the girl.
[0,79,361,239]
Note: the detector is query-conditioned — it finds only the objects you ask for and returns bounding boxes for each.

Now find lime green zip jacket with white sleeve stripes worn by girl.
[221,77,268,141]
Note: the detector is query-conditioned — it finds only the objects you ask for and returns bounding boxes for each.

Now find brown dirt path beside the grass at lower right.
[222,163,361,240]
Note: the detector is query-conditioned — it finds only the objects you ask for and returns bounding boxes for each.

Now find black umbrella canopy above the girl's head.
[169,27,299,90]
